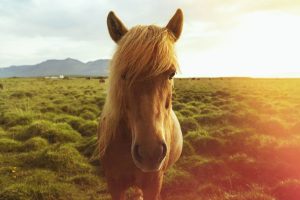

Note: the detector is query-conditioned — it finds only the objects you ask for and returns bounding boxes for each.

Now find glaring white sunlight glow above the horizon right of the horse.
[178,12,300,77]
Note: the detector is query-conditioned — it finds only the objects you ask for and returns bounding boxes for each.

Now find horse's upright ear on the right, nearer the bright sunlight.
[166,9,183,41]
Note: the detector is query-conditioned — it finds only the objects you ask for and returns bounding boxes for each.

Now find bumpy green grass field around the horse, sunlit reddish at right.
[0,78,300,200]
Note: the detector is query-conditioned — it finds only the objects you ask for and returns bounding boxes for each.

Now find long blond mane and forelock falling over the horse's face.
[98,25,178,157]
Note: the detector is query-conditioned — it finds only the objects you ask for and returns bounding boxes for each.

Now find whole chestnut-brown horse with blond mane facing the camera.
[98,9,183,200]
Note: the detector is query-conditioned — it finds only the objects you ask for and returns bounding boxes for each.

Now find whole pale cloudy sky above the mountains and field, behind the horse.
[0,0,300,77]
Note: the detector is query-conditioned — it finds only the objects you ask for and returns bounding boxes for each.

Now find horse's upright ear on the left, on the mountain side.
[107,11,128,42]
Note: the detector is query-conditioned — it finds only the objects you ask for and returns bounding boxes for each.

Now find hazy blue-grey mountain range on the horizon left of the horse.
[0,58,109,77]
